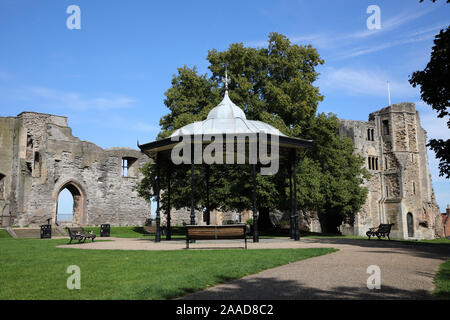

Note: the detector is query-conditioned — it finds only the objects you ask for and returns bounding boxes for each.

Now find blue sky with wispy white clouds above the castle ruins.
[0,0,450,215]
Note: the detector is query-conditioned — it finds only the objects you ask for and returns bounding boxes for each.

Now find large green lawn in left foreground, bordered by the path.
[0,239,336,300]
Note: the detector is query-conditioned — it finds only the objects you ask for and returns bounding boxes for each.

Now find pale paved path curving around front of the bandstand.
[60,238,450,300]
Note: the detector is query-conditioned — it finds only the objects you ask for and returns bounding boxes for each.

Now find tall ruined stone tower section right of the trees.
[340,103,441,239]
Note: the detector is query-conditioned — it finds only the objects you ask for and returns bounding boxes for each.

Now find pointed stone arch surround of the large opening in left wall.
[53,180,87,226]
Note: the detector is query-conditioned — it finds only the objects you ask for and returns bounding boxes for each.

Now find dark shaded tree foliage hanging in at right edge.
[409,27,450,179]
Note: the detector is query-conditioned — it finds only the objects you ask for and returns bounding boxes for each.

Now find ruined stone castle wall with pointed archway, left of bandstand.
[0,112,150,226]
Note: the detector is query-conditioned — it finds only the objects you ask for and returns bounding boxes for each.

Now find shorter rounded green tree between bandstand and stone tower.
[306,113,370,233]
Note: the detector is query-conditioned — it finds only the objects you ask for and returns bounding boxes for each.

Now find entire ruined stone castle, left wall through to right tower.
[0,103,440,239]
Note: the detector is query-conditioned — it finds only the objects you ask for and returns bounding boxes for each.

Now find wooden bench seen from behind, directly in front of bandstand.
[185,224,247,249]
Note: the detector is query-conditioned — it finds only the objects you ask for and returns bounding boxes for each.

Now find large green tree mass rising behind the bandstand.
[139,33,367,231]
